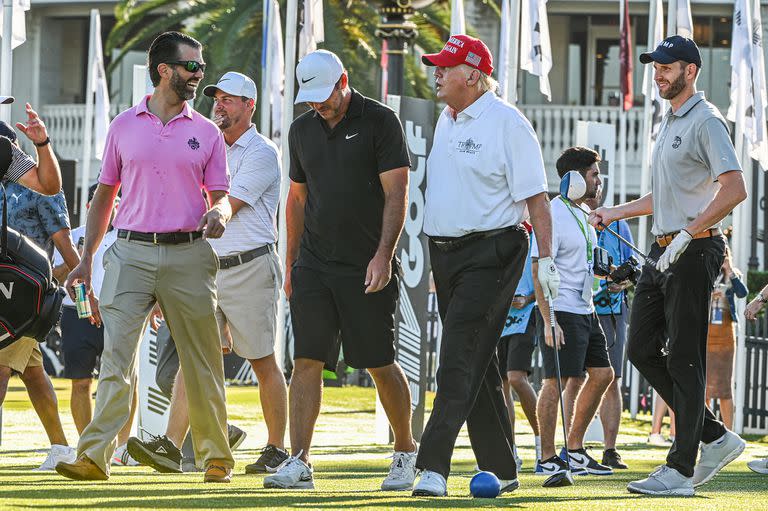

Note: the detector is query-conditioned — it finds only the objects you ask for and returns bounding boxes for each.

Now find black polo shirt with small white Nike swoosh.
[288,89,411,274]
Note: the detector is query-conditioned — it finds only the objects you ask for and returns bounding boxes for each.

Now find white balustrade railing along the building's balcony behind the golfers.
[41,104,643,198]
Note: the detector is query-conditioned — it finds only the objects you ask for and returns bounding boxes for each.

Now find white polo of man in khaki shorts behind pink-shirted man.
[208,125,280,257]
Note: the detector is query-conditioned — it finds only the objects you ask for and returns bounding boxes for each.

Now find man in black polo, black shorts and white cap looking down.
[264,50,416,490]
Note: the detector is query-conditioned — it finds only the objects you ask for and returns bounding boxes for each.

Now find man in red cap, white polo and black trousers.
[413,35,560,496]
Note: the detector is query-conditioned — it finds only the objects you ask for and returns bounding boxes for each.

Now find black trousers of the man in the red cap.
[416,227,528,479]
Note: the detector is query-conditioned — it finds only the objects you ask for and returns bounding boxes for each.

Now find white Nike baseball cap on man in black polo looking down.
[294,50,344,104]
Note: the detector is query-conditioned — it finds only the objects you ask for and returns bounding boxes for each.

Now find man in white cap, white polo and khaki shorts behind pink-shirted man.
[128,72,288,473]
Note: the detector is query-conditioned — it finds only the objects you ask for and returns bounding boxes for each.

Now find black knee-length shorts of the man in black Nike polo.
[290,266,399,370]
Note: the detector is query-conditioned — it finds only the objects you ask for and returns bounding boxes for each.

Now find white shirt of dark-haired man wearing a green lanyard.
[531,196,597,315]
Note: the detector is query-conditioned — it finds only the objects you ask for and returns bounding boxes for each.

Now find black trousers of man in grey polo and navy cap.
[627,236,725,477]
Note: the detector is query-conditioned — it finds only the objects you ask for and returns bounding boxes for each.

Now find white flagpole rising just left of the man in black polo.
[275,0,298,368]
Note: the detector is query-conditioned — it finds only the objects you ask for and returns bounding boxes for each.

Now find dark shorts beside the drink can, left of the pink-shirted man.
[61,306,104,380]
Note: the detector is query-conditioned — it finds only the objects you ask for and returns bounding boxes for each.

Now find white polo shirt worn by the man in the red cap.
[424,91,547,237]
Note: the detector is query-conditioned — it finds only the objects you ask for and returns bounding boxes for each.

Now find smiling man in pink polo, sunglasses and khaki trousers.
[56,32,234,482]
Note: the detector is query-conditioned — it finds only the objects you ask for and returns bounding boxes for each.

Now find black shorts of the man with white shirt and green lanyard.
[540,312,611,378]
